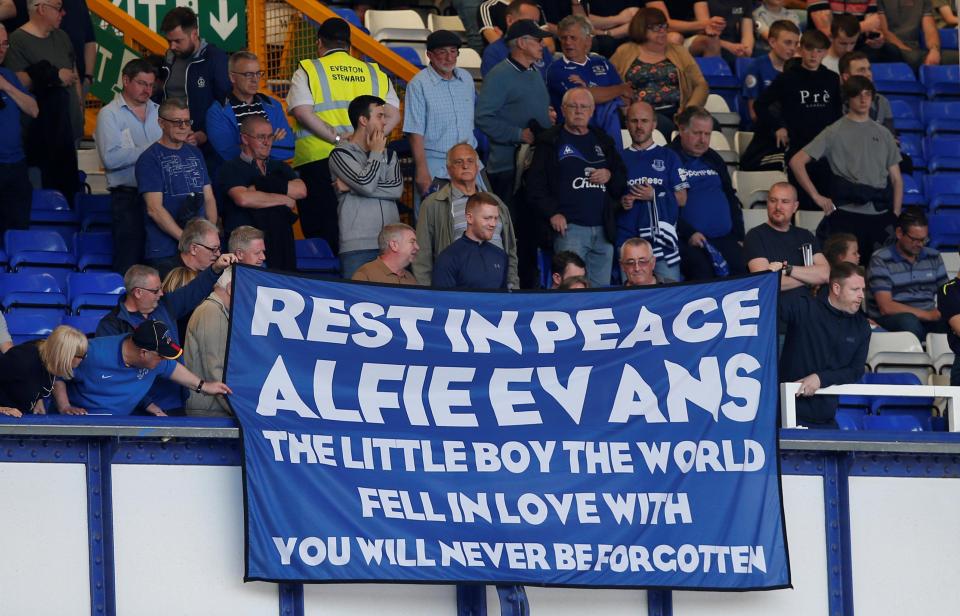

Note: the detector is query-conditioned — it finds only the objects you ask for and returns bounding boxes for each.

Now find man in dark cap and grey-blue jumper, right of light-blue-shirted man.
[477,19,551,289]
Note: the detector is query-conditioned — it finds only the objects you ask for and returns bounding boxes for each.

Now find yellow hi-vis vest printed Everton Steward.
[293,51,389,167]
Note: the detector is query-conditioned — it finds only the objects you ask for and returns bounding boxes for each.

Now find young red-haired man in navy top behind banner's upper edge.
[433,192,507,289]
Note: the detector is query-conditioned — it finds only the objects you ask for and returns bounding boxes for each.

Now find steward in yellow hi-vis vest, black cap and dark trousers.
[287,17,400,254]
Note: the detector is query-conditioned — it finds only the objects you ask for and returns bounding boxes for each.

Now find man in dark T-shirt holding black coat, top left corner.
[3,0,83,203]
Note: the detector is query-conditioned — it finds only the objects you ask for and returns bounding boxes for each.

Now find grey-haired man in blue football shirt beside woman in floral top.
[547,15,634,148]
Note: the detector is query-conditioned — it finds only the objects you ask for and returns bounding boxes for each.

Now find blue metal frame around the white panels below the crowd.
[0,418,960,616]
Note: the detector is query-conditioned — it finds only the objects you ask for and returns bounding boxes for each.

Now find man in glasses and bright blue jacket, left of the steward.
[207,51,294,161]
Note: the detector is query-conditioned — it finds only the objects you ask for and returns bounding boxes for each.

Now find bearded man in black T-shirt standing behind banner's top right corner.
[743,182,830,294]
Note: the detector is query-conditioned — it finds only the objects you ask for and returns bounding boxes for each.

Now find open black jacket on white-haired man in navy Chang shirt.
[524,126,627,244]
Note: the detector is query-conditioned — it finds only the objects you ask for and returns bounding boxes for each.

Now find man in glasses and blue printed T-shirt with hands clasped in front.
[136,98,217,278]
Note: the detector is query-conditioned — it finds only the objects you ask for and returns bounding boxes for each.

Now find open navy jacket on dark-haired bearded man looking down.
[154,41,233,132]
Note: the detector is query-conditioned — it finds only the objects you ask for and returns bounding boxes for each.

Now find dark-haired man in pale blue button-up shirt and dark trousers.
[95,58,163,272]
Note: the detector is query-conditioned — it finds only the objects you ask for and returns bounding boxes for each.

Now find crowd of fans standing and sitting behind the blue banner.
[0,0,960,425]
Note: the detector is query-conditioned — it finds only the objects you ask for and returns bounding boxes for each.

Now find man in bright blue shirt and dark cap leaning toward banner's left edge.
[53,321,233,417]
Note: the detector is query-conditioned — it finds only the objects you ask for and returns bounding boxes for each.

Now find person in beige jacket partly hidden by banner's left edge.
[183,267,233,417]
